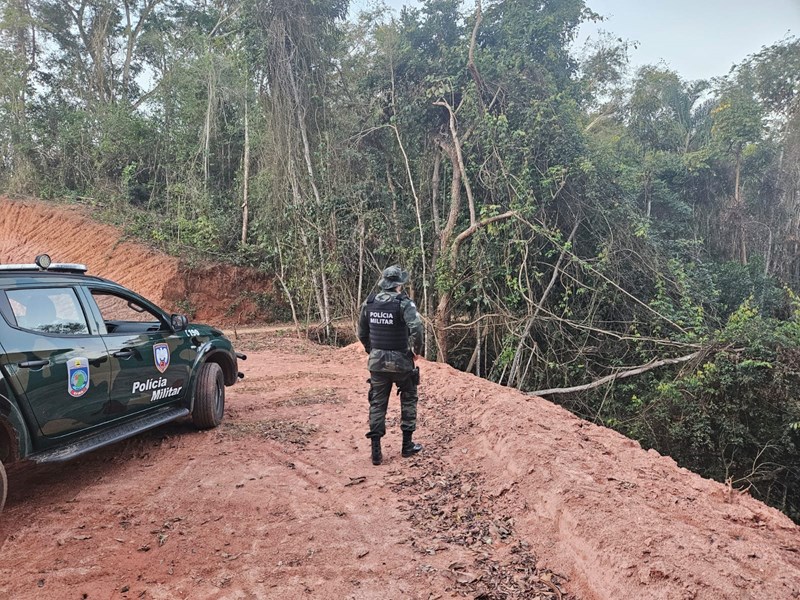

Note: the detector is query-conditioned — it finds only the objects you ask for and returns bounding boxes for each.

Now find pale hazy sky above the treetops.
[352,0,800,80]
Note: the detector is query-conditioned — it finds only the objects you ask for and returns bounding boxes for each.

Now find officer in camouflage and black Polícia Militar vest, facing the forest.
[358,265,425,465]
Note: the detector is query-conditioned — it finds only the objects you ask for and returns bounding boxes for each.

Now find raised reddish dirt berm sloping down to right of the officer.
[412,354,800,600]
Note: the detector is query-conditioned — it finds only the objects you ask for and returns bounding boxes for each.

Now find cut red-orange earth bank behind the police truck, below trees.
[0,197,280,325]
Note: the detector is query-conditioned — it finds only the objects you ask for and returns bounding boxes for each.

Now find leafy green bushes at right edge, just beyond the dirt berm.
[624,300,800,519]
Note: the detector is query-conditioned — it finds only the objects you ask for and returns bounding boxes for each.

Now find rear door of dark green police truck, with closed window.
[0,287,113,437]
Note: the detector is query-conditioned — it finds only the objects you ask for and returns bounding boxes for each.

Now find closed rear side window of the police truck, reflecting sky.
[6,288,89,335]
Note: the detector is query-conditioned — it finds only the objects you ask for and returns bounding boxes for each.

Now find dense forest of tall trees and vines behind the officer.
[0,0,800,519]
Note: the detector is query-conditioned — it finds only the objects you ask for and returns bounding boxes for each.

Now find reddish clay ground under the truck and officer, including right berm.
[0,332,800,600]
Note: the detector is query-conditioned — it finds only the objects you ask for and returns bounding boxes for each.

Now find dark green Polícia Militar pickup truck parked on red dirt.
[0,255,246,511]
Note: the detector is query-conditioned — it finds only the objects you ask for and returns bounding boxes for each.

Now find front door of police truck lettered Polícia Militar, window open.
[87,286,196,414]
